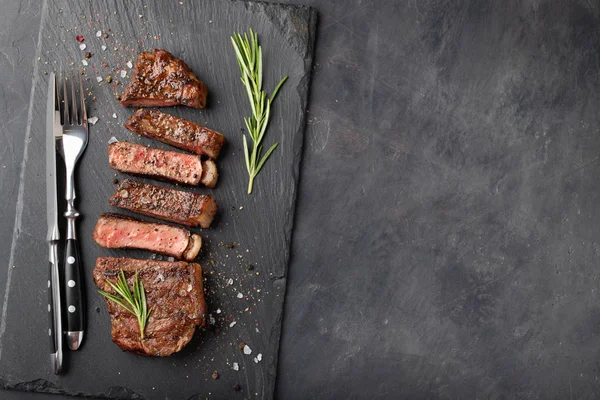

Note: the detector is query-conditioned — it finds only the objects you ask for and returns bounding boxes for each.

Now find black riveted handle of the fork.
[64,238,85,350]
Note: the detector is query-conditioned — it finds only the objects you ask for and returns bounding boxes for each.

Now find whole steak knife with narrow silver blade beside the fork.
[46,73,63,375]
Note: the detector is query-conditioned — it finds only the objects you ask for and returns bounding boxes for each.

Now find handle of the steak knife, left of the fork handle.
[48,242,62,375]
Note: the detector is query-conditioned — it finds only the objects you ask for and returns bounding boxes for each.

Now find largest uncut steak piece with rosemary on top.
[93,257,207,357]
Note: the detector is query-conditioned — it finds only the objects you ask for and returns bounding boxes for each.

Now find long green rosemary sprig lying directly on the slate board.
[231,29,288,194]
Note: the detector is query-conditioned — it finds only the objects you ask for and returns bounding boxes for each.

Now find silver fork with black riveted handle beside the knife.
[56,75,88,350]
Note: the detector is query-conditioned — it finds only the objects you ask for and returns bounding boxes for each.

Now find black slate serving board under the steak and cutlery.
[0,0,316,398]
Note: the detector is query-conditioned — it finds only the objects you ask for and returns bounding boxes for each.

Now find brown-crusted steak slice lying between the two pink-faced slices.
[109,179,217,228]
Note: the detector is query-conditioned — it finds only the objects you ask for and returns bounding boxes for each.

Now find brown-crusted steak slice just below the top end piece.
[125,109,225,158]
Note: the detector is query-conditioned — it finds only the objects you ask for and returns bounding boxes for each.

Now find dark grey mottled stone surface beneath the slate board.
[0,0,600,399]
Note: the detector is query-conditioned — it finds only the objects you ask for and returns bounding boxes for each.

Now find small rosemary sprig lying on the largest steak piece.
[98,270,152,340]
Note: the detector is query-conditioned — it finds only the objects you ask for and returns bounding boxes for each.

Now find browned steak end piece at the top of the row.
[121,49,208,108]
